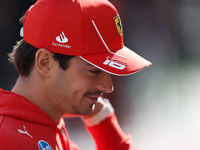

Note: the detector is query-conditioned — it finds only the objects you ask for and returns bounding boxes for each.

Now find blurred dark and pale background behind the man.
[0,0,200,150]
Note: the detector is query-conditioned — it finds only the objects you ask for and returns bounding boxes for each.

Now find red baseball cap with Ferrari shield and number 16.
[23,0,151,75]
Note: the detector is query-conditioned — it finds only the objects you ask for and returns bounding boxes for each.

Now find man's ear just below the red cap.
[35,48,55,78]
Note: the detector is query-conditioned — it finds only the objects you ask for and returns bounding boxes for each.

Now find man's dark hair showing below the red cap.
[8,39,75,76]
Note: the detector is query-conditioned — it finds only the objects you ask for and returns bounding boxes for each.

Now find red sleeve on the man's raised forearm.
[87,112,137,150]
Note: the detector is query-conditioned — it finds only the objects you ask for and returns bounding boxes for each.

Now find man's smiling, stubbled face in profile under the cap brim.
[51,57,113,115]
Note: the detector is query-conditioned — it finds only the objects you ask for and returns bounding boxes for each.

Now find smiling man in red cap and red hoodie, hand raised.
[0,0,151,150]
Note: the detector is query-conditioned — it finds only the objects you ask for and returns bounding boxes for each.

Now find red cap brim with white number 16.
[79,46,152,76]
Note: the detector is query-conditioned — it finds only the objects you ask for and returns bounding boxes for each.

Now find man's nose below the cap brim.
[97,72,114,93]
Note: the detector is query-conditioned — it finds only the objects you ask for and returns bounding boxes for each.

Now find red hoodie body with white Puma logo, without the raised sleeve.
[0,90,80,150]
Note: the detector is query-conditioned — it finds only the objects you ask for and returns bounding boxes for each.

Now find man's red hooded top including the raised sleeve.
[0,89,137,150]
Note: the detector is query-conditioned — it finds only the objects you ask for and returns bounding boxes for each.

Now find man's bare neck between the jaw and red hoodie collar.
[12,76,64,124]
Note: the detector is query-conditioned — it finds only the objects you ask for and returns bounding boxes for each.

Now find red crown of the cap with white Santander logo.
[23,0,123,56]
